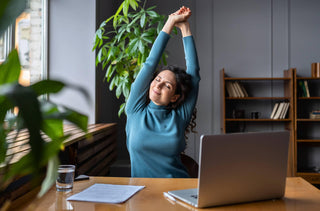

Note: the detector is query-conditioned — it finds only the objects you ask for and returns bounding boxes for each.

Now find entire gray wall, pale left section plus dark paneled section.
[49,0,320,165]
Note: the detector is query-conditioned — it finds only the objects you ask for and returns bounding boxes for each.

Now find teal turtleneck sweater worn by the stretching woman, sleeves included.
[126,31,200,178]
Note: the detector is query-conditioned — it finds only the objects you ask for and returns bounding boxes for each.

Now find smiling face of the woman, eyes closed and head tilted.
[149,70,179,106]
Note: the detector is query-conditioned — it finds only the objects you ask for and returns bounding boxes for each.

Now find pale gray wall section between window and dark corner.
[48,0,96,123]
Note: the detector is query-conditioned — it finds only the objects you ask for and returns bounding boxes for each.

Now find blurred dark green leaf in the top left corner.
[0,0,27,36]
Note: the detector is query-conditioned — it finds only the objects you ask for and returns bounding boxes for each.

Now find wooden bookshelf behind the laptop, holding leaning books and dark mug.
[220,69,295,176]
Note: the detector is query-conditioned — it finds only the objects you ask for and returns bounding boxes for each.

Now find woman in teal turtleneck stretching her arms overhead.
[126,7,200,178]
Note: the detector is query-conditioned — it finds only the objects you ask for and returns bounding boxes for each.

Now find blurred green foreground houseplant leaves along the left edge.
[0,0,88,207]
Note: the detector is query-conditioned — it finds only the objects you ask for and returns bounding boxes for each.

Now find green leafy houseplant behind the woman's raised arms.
[93,0,172,116]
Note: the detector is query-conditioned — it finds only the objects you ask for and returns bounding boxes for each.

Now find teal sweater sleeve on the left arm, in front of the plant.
[126,31,170,114]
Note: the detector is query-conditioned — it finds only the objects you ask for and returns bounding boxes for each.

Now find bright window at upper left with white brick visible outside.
[0,0,48,86]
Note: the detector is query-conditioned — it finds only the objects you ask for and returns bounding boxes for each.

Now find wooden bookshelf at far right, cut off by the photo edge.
[294,70,320,185]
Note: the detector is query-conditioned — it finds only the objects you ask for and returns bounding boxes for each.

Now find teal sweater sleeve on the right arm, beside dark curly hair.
[178,36,200,124]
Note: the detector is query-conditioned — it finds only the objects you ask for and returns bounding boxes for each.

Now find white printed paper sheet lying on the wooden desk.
[67,183,145,204]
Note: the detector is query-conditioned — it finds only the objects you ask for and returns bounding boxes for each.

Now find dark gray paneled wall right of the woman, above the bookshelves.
[163,0,320,162]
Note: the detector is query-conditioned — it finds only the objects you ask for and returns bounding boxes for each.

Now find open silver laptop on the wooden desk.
[168,131,290,208]
